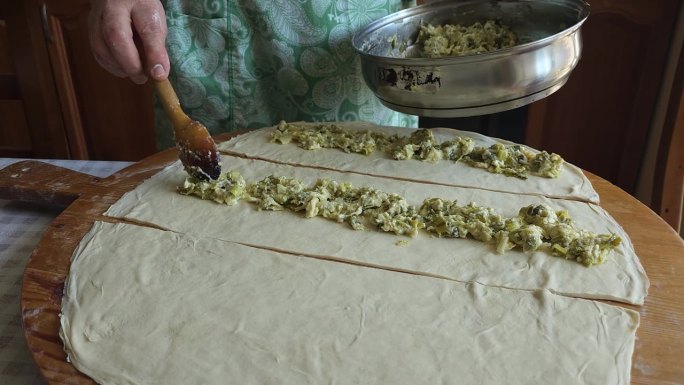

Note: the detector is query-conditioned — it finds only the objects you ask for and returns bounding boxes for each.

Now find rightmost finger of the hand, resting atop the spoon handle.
[131,1,170,80]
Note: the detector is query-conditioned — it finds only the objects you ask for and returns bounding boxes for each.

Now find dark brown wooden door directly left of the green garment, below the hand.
[42,0,156,161]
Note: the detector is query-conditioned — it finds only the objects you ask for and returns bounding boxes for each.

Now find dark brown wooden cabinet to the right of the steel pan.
[526,0,681,193]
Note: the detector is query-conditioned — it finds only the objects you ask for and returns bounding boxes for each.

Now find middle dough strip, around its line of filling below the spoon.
[106,156,648,304]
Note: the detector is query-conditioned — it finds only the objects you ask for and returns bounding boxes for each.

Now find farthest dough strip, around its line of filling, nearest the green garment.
[218,122,599,203]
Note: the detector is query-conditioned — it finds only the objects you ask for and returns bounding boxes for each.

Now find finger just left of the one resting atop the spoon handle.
[101,1,147,84]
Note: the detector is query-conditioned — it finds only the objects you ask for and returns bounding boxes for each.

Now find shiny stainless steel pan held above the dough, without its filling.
[352,0,589,117]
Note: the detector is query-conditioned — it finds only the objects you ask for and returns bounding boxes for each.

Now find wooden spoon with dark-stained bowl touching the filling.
[154,79,221,180]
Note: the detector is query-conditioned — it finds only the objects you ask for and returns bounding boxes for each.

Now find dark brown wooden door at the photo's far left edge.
[0,1,70,158]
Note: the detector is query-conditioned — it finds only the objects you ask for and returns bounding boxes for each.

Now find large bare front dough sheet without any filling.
[60,222,639,385]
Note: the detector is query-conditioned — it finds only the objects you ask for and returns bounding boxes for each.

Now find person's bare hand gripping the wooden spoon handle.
[88,0,170,84]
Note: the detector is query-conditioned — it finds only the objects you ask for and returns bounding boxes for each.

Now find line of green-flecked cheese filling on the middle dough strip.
[178,171,621,266]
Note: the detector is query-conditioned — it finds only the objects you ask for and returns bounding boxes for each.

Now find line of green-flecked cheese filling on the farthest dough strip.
[271,122,563,179]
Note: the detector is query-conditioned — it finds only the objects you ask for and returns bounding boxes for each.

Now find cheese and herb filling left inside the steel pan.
[417,20,518,58]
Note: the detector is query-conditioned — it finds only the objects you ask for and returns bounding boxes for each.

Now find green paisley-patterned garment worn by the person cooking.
[157,0,417,148]
